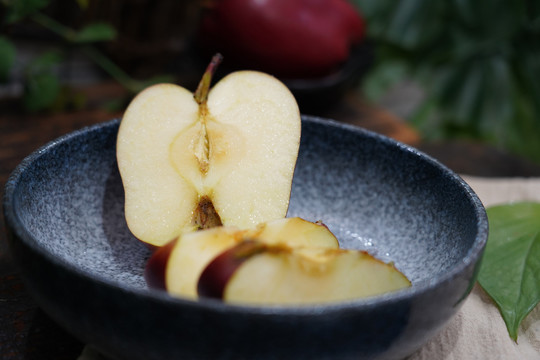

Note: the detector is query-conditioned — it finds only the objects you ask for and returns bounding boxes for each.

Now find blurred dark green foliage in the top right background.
[353,0,540,163]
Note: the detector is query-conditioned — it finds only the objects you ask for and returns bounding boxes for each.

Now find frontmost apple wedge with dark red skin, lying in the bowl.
[197,240,411,305]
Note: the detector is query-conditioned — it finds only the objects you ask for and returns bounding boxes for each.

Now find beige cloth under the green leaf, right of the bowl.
[408,176,540,360]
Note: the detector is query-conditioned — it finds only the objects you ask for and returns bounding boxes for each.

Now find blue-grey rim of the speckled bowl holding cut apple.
[3,115,488,316]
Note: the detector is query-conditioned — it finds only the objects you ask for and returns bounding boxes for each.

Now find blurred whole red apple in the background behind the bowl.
[199,0,366,78]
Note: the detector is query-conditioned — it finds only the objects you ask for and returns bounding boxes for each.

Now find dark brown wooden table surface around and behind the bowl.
[0,83,540,360]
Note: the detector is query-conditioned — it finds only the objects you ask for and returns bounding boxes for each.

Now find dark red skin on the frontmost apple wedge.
[197,240,266,299]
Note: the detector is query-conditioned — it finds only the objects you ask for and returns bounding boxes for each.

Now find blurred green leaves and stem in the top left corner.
[0,0,169,112]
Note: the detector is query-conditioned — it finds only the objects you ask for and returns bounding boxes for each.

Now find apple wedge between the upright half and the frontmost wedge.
[145,218,339,298]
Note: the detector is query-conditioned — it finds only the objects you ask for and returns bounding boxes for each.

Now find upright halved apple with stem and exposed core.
[117,57,301,246]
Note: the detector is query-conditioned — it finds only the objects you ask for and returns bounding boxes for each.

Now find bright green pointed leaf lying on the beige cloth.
[478,202,540,340]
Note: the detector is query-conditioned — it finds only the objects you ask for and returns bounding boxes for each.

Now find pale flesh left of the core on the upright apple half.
[116,84,198,246]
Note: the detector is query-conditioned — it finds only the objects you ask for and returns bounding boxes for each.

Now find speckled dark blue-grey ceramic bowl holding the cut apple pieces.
[4,117,488,360]
